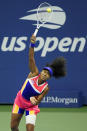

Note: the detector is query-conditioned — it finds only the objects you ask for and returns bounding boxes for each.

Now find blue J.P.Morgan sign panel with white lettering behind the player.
[40,91,82,107]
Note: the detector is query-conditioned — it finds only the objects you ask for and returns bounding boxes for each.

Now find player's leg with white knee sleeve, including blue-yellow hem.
[26,110,36,131]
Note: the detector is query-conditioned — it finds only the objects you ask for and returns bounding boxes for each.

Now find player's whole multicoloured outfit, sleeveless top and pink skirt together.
[12,74,48,115]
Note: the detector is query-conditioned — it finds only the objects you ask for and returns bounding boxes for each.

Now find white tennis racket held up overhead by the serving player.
[33,2,52,36]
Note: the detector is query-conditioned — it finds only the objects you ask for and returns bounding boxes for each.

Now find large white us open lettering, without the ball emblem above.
[1,36,86,57]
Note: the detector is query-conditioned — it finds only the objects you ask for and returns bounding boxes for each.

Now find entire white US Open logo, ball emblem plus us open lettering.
[0,6,87,57]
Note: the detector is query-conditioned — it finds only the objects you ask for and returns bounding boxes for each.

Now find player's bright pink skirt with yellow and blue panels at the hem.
[12,91,40,115]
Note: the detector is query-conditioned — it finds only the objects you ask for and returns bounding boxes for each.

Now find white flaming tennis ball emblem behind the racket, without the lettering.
[20,6,66,29]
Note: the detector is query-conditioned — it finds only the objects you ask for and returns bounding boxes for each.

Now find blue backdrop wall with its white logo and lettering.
[0,0,87,107]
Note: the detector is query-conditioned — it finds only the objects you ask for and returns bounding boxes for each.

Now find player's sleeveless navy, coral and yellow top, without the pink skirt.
[21,74,48,100]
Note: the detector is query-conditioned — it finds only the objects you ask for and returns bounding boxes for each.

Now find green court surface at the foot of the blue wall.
[0,105,87,131]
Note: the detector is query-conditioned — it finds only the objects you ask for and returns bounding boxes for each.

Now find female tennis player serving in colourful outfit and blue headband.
[11,35,66,131]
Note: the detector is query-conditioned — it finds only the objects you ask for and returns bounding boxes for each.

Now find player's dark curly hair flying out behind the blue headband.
[46,57,66,78]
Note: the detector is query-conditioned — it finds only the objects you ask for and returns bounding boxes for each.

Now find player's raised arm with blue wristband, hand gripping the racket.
[28,35,39,77]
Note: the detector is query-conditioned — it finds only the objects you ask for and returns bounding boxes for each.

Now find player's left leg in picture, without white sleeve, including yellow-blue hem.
[11,104,24,131]
